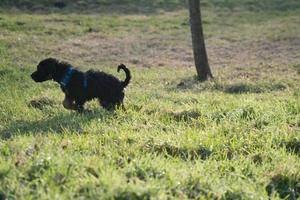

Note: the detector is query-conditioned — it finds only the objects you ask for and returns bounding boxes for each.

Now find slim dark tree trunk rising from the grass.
[189,0,213,81]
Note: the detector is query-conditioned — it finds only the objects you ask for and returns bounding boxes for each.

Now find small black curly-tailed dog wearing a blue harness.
[31,58,131,112]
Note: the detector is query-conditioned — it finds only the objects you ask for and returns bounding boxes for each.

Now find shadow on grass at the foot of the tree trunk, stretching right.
[175,79,287,94]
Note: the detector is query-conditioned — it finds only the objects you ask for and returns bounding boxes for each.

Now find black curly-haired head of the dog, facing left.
[31,58,59,82]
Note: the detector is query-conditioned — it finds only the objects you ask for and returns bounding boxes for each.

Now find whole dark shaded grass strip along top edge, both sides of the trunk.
[0,0,300,15]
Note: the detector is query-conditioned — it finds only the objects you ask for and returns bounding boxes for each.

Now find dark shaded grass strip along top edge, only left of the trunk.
[0,0,186,15]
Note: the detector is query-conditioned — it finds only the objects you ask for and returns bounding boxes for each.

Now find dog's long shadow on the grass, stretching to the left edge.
[0,111,114,139]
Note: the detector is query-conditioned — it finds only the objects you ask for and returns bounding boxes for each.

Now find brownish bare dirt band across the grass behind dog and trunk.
[54,33,300,70]
